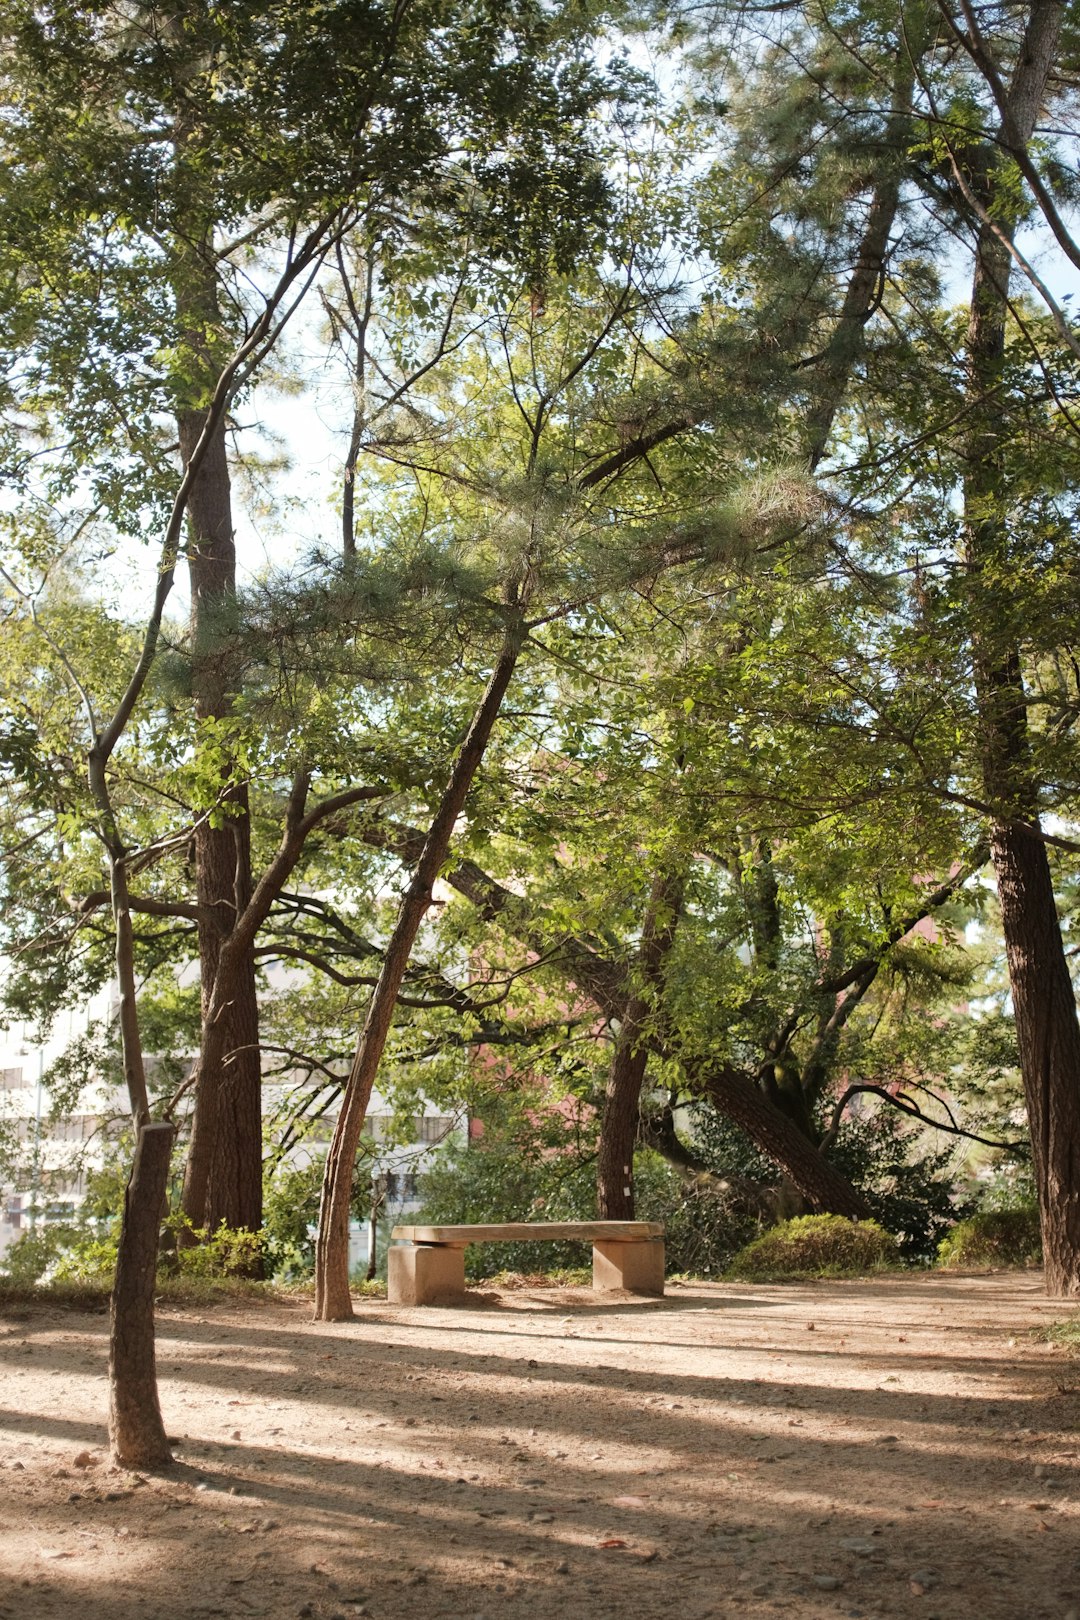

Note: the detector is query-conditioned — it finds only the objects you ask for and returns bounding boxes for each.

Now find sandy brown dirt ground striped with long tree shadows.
[0,1273,1080,1620]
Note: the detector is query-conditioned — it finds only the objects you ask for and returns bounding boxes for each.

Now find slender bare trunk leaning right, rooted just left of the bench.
[316,620,525,1322]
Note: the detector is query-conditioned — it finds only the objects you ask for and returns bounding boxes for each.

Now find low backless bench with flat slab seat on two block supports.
[387,1220,664,1306]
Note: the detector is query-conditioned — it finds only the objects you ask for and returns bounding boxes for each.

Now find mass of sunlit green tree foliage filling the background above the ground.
[0,0,1080,1302]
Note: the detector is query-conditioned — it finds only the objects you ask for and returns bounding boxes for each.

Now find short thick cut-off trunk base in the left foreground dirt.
[108,1124,173,1468]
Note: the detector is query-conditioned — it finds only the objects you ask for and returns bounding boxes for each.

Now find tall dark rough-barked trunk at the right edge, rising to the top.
[963,0,1080,1296]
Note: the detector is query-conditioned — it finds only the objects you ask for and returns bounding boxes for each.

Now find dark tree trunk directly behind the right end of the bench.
[596,875,682,1220]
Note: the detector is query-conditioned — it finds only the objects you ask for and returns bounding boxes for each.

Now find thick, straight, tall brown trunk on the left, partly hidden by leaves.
[178,265,262,1250]
